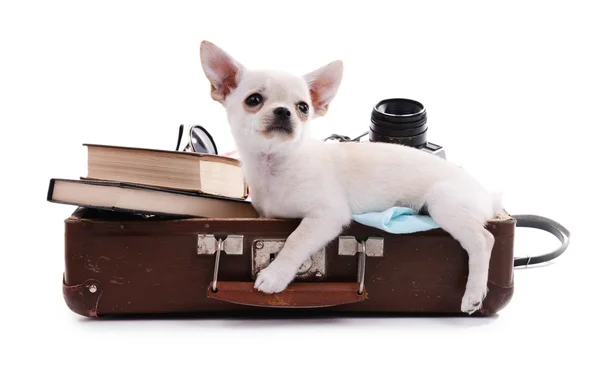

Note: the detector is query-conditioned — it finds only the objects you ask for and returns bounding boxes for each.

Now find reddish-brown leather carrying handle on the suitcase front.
[208,281,367,308]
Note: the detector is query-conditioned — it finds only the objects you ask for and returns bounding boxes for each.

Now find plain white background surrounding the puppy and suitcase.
[0,0,600,369]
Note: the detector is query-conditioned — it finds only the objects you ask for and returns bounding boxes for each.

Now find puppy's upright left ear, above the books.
[200,41,244,104]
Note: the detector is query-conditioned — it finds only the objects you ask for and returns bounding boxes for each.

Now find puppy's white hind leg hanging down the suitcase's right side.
[426,181,494,314]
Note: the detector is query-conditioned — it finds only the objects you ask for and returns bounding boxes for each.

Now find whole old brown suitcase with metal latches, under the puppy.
[63,208,552,317]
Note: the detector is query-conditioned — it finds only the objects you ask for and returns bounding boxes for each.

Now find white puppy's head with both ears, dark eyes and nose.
[200,41,343,147]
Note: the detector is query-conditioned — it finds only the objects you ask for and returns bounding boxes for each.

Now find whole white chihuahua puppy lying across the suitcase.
[200,41,501,314]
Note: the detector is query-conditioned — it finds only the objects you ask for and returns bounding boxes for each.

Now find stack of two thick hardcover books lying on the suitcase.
[47,144,258,218]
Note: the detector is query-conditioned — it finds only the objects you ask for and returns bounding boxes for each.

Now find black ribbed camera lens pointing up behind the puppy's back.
[369,98,427,148]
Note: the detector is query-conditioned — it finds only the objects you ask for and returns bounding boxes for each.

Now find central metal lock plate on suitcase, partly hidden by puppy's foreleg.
[252,239,325,280]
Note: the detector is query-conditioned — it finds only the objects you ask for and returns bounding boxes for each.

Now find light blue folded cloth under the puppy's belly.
[352,207,439,234]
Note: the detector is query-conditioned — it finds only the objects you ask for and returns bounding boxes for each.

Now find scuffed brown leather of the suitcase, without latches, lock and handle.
[64,209,515,316]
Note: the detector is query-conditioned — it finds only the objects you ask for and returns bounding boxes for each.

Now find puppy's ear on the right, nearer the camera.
[303,60,344,116]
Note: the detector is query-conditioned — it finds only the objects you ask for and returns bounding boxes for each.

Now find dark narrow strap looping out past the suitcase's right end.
[511,215,571,267]
